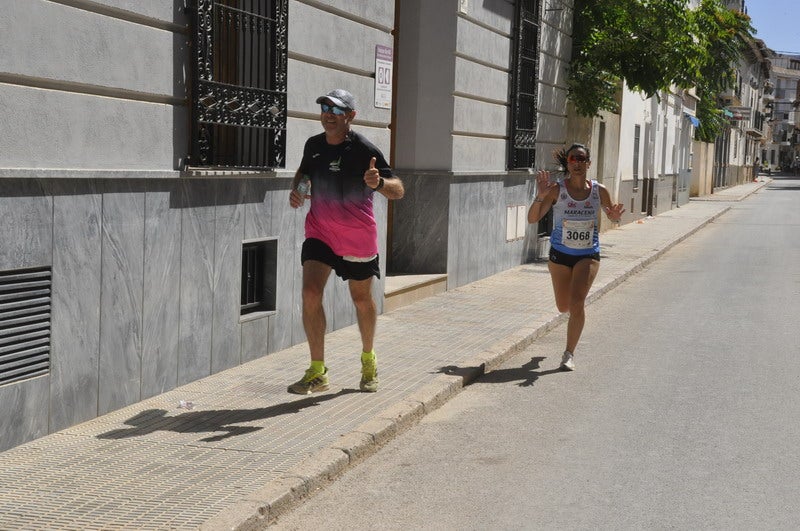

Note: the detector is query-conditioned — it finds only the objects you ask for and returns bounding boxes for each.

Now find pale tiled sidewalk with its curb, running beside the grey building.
[0,183,765,531]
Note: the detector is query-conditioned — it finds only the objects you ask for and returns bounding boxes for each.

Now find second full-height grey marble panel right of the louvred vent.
[98,180,145,415]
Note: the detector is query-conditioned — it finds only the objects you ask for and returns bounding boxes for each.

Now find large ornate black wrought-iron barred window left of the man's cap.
[189,0,288,169]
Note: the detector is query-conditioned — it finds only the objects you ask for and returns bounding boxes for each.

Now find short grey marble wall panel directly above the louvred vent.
[0,179,53,270]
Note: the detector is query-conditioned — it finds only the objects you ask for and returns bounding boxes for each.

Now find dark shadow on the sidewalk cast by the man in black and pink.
[97,389,358,442]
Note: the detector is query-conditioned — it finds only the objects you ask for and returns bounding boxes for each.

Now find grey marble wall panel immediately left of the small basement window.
[211,180,246,373]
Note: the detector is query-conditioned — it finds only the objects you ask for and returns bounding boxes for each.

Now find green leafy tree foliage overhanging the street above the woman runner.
[569,0,753,140]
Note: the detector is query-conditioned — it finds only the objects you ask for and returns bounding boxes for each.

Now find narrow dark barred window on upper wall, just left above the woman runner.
[508,0,539,169]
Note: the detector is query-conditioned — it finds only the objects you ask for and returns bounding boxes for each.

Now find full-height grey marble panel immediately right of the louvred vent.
[48,180,103,431]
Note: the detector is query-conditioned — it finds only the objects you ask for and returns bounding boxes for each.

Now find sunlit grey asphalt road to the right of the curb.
[274,178,800,530]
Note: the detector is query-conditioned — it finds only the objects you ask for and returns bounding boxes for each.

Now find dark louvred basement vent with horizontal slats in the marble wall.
[0,267,52,385]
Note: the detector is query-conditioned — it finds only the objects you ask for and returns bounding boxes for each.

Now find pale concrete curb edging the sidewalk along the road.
[200,202,736,531]
